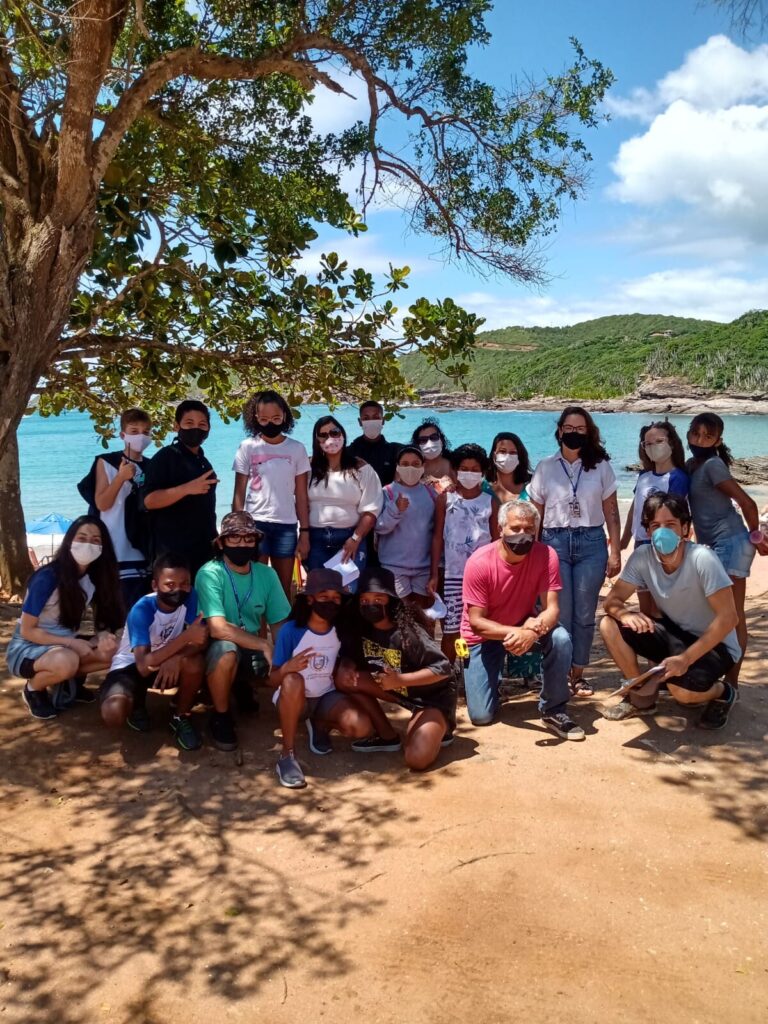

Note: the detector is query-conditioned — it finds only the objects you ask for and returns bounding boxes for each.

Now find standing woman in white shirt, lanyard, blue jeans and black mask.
[528,406,622,696]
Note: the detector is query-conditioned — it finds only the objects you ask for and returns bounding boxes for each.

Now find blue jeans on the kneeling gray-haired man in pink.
[464,626,572,725]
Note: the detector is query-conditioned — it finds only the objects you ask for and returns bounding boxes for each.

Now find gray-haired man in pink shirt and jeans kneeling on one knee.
[461,500,584,739]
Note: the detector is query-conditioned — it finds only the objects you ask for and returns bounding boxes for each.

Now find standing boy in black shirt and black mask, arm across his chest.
[141,398,218,580]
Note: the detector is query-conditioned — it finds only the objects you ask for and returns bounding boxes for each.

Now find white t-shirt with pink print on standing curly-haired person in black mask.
[232,437,309,523]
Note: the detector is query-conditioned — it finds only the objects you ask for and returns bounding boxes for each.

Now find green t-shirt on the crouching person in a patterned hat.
[195,559,291,633]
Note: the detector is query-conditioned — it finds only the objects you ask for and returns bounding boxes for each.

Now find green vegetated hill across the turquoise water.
[402,310,768,399]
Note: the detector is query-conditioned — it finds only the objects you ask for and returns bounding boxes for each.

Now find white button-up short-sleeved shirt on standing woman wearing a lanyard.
[528,452,616,529]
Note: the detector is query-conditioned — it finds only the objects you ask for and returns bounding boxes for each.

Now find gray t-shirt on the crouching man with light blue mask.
[620,542,741,660]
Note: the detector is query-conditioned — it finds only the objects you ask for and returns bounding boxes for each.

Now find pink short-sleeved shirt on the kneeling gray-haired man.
[461,541,562,643]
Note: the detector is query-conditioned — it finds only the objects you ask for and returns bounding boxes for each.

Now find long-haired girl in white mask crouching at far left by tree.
[6,515,125,720]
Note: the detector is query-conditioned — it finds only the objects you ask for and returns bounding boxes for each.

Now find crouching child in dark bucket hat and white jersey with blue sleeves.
[269,568,374,790]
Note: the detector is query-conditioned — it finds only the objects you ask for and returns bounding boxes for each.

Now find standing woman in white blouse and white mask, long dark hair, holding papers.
[306,416,383,589]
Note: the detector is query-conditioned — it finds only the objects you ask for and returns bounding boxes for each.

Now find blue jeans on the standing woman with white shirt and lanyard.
[542,526,608,669]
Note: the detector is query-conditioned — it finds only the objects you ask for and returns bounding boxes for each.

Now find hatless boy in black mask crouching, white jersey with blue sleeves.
[100,554,208,751]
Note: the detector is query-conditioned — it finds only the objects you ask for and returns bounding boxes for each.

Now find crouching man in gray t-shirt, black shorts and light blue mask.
[600,494,741,729]
